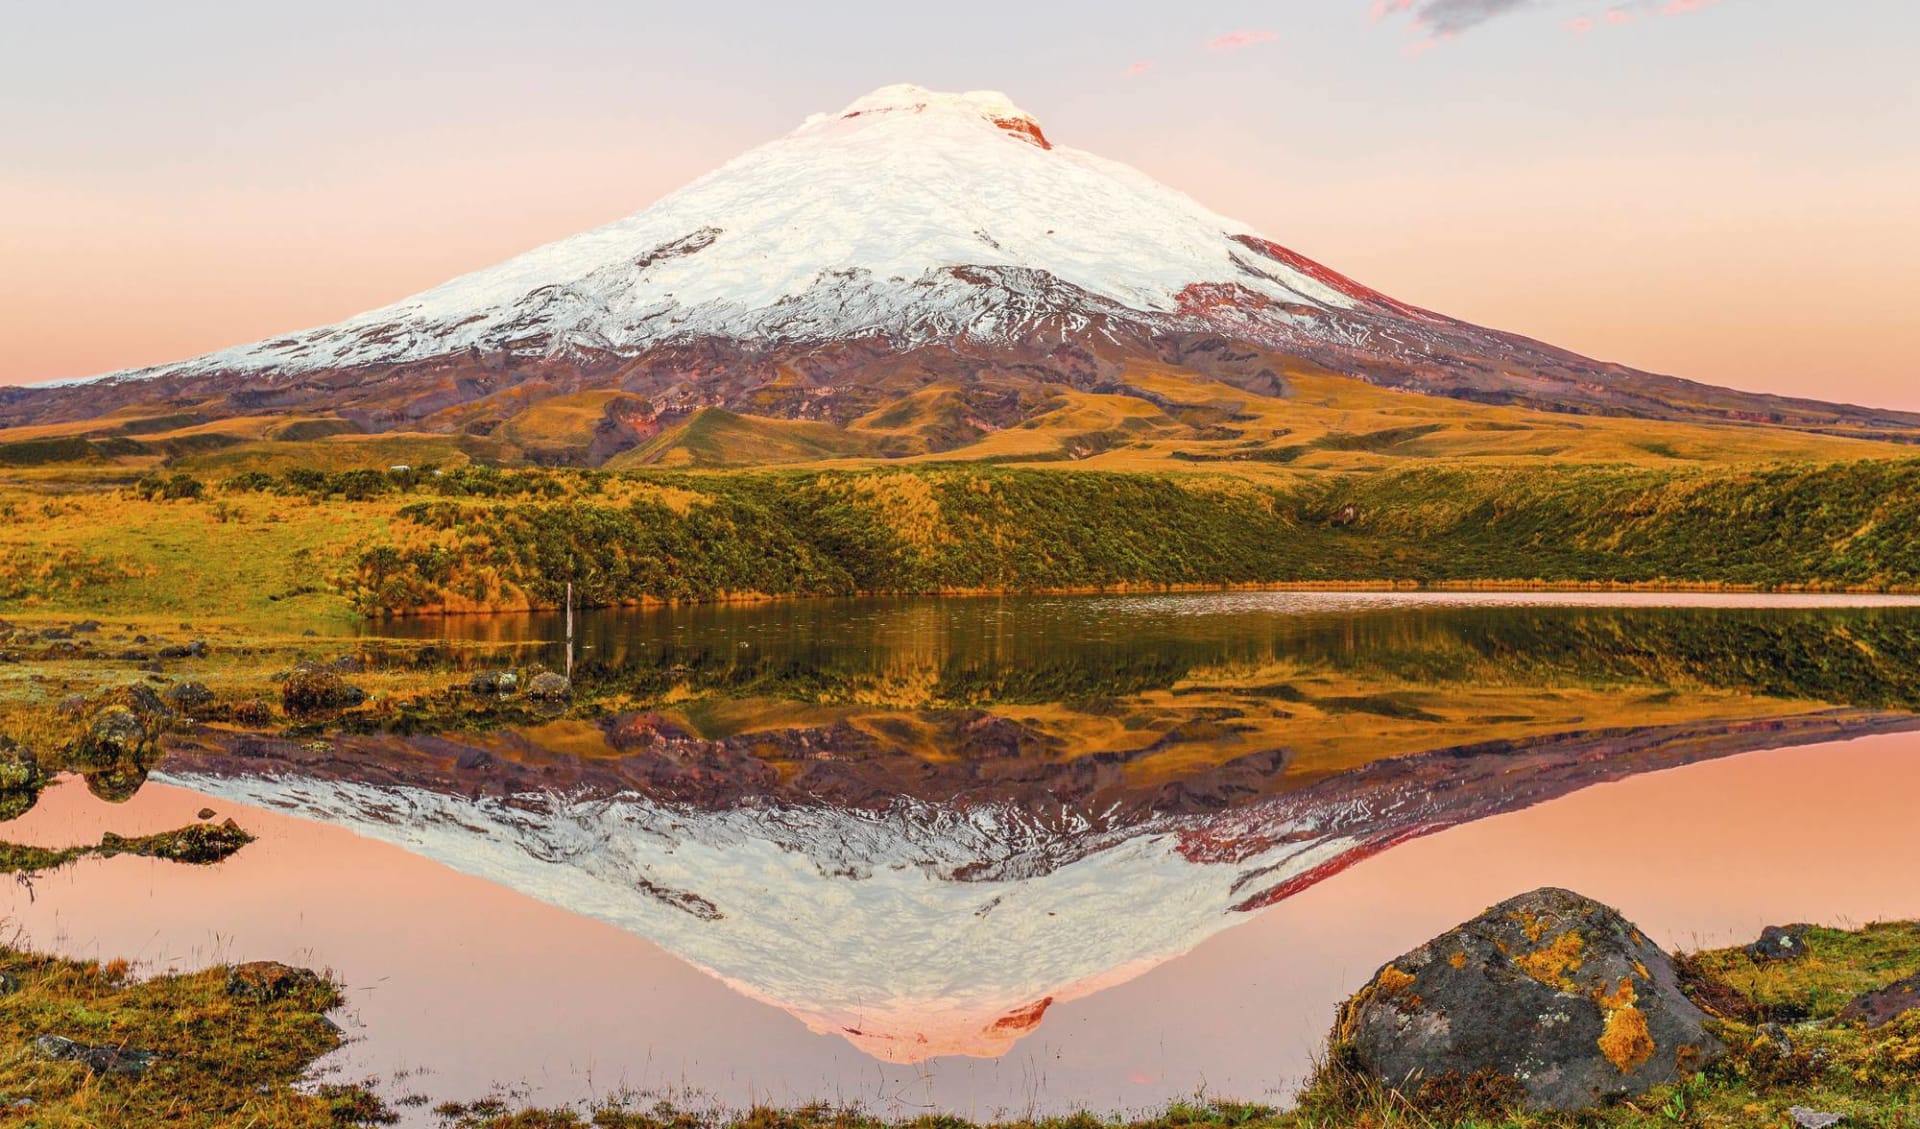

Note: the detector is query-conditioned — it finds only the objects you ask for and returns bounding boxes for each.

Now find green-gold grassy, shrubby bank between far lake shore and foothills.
[0,459,1920,634]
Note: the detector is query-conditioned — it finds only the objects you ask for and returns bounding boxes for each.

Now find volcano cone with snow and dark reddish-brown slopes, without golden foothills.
[0,86,1920,461]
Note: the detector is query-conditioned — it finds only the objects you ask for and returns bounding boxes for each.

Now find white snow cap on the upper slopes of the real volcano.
[86,84,1373,376]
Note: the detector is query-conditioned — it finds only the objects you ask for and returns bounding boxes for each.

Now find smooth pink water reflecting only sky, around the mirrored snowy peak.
[0,733,1920,1116]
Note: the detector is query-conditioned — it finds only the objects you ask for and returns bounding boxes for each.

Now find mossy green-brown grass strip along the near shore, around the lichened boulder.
[0,922,1920,1129]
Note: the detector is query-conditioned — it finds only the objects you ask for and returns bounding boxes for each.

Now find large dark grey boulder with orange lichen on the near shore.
[1334,889,1724,1110]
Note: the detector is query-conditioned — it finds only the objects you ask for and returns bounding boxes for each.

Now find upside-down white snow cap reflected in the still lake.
[156,774,1352,1062]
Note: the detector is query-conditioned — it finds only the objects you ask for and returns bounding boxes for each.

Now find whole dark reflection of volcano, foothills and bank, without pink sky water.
[105,597,1920,1062]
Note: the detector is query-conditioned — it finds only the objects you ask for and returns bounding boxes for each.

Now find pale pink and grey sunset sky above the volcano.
[0,0,1920,409]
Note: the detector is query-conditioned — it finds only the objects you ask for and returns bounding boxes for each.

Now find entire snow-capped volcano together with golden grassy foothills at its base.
[0,86,1920,467]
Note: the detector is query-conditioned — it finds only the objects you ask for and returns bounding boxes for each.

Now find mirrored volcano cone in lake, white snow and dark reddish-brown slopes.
[156,710,1920,1062]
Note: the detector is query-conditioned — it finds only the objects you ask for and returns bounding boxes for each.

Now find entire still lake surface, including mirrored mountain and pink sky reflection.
[0,593,1920,1116]
